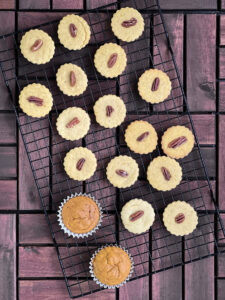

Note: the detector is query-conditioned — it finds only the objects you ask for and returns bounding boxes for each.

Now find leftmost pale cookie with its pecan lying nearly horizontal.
[19,83,53,118]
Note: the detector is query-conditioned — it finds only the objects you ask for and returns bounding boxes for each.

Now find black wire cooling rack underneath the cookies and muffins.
[0,0,225,298]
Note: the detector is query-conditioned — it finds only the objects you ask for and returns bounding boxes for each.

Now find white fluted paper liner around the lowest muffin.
[89,244,134,289]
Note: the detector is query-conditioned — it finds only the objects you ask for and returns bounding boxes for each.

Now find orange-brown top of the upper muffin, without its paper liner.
[62,196,100,233]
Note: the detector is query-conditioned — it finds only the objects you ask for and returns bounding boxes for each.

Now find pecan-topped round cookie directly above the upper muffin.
[64,147,97,181]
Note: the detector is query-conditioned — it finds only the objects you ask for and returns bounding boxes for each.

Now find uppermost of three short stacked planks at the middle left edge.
[0,114,16,144]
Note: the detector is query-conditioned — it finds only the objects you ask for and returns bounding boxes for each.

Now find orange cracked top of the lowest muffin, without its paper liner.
[93,246,131,286]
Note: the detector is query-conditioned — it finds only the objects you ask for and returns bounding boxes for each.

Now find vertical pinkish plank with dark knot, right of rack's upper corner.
[187,15,216,111]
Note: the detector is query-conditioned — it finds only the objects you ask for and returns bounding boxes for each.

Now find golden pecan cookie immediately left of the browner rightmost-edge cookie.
[125,121,158,154]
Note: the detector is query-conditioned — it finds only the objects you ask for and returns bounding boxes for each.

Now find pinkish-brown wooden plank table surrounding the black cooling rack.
[0,0,225,300]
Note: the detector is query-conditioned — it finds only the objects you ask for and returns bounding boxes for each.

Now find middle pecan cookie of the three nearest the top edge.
[58,15,91,50]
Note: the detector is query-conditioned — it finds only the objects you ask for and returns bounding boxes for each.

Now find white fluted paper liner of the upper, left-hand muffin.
[57,193,102,238]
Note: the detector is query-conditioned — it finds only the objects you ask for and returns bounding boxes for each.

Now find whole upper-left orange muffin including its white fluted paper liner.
[58,194,102,237]
